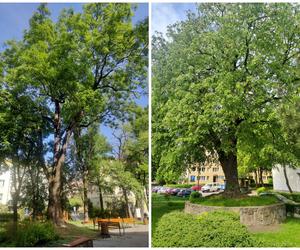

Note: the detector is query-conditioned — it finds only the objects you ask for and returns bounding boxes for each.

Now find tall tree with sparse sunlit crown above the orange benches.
[3,3,147,224]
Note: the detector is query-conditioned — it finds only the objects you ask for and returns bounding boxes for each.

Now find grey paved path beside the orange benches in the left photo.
[93,225,149,247]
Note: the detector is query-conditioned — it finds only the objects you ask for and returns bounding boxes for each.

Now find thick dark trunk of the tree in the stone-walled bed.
[218,151,241,197]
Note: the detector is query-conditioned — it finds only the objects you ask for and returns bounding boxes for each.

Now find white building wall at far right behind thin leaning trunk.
[272,166,300,192]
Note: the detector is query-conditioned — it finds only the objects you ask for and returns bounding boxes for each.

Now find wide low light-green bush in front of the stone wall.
[153,211,260,247]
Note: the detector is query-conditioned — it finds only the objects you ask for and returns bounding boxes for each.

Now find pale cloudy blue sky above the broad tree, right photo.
[151,3,196,35]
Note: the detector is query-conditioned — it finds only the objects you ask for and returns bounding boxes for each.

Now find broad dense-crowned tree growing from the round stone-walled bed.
[152,3,300,196]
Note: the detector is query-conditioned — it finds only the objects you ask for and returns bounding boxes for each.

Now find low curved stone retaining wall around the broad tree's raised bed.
[184,201,286,226]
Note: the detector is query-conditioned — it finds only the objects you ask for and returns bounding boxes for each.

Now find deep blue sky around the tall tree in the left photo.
[0,3,148,153]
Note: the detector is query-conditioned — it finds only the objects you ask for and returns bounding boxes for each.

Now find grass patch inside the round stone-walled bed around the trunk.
[193,195,278,207]
